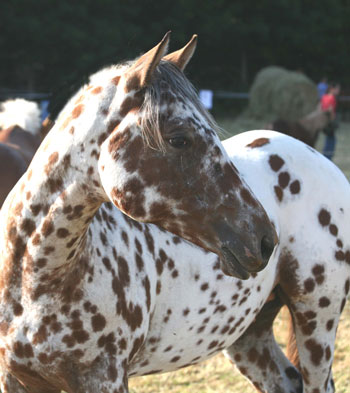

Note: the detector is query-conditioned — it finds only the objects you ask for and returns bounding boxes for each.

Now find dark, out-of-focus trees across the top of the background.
[0,0,350,115]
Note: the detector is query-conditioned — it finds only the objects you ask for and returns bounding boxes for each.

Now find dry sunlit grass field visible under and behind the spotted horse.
[129,120,350,393]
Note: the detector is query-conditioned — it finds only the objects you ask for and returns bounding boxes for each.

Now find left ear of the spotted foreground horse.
[127,31,170,90]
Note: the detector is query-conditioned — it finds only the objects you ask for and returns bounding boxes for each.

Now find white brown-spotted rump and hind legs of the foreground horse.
[224,131,350,393]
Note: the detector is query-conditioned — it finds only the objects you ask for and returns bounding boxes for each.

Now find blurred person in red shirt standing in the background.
[321,84,340,160]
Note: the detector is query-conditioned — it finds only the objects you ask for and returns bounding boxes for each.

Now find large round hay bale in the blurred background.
[245,66,319,122]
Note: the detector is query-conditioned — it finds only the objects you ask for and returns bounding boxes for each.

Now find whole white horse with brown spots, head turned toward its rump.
[0,33,350,393]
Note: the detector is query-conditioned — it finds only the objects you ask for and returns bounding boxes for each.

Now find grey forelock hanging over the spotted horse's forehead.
[140,61,221,151]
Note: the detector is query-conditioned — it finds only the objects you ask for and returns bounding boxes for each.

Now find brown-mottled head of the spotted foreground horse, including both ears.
[98,33,276,278]
